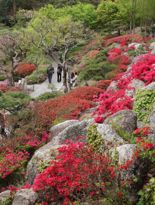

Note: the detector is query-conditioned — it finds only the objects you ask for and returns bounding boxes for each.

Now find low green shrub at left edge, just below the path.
[0,92,30,112]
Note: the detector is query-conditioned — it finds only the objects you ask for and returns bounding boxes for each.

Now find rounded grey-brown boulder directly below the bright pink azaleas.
[104,110,137,133]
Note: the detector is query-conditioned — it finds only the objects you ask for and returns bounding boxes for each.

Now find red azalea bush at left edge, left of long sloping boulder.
[0,132,48,188]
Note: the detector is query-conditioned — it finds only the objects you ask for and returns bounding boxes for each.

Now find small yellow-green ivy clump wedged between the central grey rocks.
[87,125,104,152]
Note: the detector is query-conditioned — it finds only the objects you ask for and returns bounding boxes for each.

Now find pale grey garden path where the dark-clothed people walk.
[27,64,63,98]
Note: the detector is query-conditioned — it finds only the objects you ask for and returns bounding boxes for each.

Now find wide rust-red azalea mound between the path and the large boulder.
[35,86,103,128]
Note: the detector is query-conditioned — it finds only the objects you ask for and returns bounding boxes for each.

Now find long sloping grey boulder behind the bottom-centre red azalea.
[26,120,92,184]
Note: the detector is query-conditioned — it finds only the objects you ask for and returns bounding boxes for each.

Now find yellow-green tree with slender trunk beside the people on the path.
[22,16,86,89]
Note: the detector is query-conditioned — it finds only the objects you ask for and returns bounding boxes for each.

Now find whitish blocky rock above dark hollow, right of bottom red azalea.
[116,144,136,164]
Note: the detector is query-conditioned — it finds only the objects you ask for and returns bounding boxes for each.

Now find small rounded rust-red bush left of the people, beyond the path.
[15,63,36,77]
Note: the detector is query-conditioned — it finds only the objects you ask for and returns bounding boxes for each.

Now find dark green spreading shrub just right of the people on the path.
[79,51,116,81]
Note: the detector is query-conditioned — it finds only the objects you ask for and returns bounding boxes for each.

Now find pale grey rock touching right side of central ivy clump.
[97,123,124,145]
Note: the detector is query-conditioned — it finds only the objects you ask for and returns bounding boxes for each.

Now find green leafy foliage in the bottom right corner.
[137,177,155,205]
